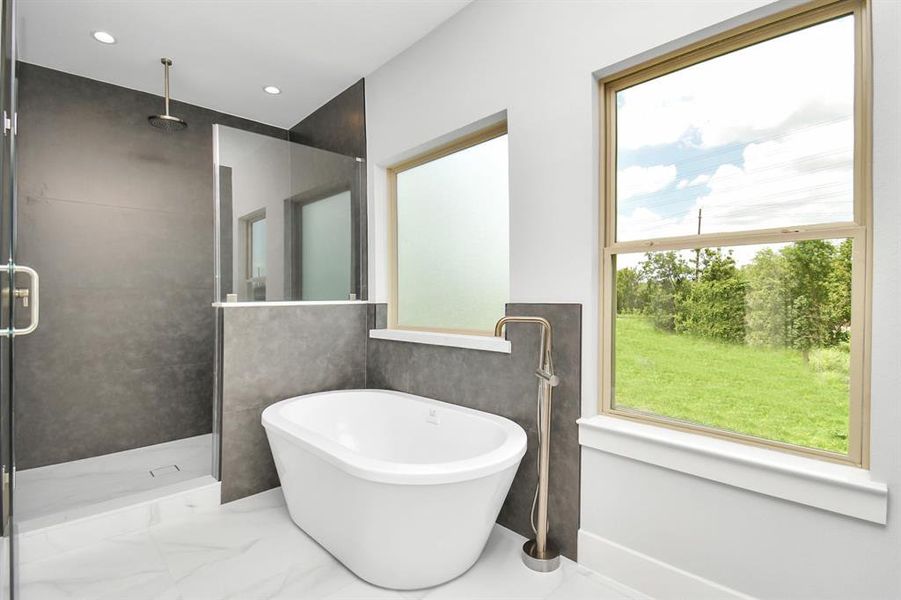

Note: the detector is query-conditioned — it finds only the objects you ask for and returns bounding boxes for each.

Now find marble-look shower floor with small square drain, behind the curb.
[16,434,213,528]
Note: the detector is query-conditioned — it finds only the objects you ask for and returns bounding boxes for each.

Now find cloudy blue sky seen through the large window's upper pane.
[616,16,854,264]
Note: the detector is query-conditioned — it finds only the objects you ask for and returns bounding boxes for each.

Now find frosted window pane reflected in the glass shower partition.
[301,191,351,300]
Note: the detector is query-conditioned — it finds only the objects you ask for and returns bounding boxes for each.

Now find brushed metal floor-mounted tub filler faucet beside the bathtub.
[494,316,560,573]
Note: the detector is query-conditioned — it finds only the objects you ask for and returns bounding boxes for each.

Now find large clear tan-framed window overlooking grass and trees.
[601,1,870,466]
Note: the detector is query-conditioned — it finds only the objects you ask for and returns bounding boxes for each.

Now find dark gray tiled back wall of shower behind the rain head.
[16,63,287,469]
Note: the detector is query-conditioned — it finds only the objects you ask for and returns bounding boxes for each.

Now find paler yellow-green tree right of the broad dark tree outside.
[742,248,791,347]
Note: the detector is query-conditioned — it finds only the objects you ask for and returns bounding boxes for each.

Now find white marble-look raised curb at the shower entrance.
[15,475,221,564]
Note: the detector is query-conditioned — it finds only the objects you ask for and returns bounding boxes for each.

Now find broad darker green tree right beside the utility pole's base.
[675,248,747,343]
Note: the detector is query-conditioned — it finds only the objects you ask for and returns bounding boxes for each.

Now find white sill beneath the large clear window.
[578,415,888,525]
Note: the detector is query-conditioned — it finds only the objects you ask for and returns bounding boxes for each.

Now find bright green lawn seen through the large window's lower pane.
[614,315,849,453]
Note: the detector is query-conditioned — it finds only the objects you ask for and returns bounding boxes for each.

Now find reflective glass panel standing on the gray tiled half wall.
[214,125,366,302]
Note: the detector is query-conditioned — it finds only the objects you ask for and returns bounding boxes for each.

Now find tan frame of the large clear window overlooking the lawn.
[598,0,873,468]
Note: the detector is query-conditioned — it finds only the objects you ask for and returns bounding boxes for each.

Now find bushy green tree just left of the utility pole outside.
[639,251,691,331]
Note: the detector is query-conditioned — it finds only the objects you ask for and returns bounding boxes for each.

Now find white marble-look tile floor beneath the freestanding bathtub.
[19,489,639,600]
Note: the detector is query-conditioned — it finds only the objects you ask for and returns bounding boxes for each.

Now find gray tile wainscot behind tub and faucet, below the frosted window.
[366,304,582,559]
